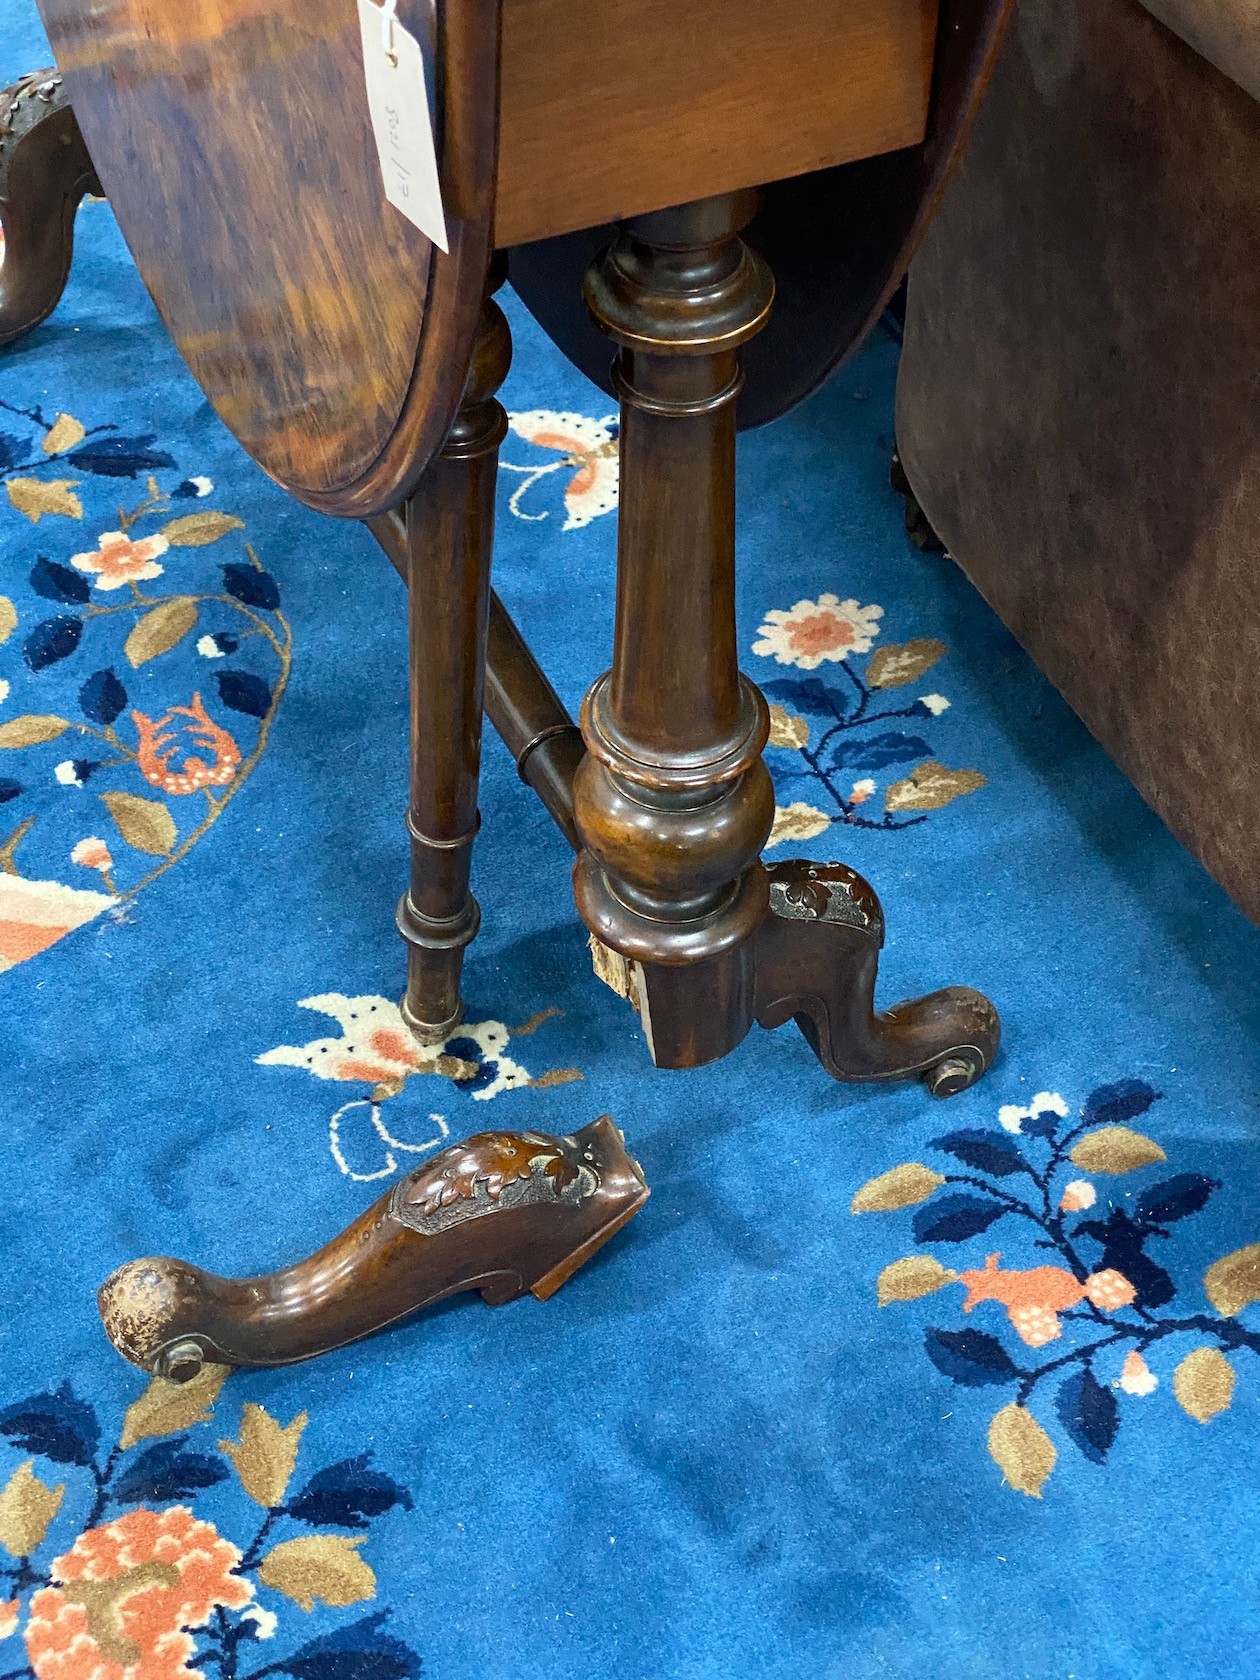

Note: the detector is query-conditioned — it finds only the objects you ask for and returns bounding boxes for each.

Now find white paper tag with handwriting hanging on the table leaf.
[360,0,450,250]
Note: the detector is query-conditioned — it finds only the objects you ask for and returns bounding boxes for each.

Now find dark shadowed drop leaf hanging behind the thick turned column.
[511,0,1011,427]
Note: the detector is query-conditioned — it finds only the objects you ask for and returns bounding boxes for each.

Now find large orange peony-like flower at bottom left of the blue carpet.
[25,1505,254,1680]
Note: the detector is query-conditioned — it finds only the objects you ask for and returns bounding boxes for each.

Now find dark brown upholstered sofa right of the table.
[897,0,1260,921]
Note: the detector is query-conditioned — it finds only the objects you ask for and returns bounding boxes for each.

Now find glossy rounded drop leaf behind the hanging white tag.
[40,0,499,517]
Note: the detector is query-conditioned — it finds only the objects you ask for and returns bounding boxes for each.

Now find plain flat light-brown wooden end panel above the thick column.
[494,0,936,247]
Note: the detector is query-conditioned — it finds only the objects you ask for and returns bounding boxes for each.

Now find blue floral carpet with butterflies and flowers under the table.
[0,0,1260,1680]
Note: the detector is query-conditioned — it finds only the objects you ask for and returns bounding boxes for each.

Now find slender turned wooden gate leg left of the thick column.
[398,297,512,1043]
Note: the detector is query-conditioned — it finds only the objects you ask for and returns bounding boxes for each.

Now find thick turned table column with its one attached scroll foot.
[575,193,998,1095]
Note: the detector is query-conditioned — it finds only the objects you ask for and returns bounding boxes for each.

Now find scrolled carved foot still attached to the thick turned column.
[754,858,1001,1097]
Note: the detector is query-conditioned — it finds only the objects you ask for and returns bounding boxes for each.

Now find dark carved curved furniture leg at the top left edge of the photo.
[0,71,101,344]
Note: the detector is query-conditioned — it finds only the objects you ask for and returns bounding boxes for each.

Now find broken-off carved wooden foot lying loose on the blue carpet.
[97,1114,648,1383]
